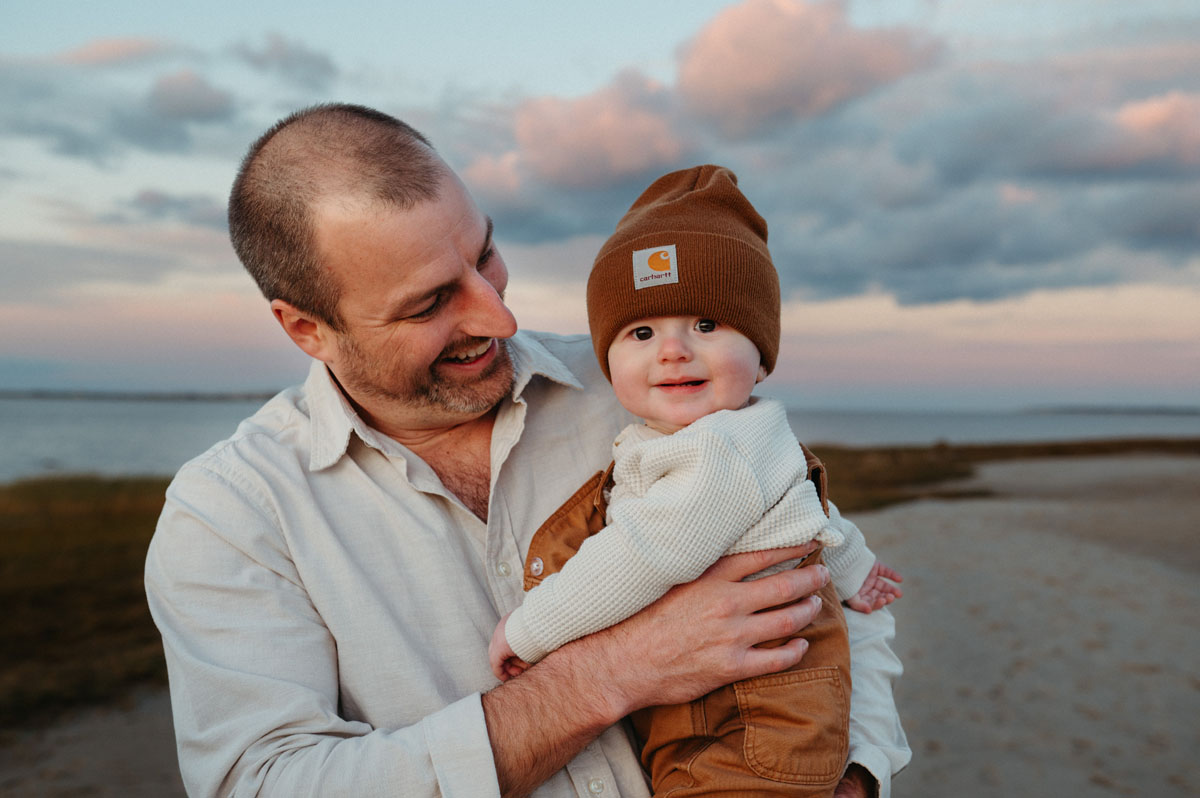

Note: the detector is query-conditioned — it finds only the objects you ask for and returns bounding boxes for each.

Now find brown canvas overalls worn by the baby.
[524,444,850,798]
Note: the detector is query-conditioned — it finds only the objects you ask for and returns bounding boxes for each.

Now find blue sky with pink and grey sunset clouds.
[0,0,1200,409]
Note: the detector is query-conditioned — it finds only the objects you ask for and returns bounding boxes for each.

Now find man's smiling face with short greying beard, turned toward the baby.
[316,170,517,433]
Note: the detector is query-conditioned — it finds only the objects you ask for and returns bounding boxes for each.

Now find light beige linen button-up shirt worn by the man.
[146,332,908,798]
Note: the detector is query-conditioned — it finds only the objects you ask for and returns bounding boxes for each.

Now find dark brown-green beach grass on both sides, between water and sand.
[0,439,1200,731]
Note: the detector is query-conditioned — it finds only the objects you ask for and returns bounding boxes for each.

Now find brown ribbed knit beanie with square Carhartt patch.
[588,166,779,382]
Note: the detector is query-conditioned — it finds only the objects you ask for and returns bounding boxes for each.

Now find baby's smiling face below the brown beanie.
[608,316,767,434]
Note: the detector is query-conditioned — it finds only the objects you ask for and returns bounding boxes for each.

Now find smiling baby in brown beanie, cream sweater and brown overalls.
[488,166,901,798]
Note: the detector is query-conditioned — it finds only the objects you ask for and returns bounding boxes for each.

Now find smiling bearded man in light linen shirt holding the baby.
[146,106,908,797]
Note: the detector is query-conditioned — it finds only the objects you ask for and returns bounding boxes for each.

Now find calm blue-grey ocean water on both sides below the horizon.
[0,398,1200,482]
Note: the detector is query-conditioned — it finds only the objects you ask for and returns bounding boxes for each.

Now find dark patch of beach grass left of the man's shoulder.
[0,476,168,728]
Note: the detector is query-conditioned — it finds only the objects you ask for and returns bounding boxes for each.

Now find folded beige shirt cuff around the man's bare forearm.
[424,692,500,798]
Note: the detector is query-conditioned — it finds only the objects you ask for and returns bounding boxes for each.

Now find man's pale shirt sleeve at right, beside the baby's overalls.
[829,504,912,798]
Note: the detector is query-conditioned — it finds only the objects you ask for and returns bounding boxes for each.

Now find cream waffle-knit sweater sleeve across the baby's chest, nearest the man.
[505,427,767,662]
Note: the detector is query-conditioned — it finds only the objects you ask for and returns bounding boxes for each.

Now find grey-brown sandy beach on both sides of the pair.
[0,455,1200,798]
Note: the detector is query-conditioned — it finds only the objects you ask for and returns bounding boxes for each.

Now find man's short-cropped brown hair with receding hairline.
[229,103,446,331]
